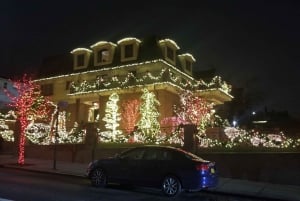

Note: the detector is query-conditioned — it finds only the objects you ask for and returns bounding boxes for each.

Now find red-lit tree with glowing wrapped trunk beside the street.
[5,74,52,165]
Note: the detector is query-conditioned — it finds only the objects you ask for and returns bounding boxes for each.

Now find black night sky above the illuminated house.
[0,0,300,117]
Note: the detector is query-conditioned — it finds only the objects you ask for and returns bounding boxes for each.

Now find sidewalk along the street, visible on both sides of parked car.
[0,155,300,201]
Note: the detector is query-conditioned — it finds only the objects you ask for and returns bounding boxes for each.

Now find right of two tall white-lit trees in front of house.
[138,89,160,143]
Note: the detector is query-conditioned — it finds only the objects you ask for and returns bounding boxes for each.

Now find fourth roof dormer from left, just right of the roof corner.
[158,39,180,65]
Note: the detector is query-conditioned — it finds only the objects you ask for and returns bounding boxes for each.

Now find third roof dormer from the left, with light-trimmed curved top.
[117,38,141,62]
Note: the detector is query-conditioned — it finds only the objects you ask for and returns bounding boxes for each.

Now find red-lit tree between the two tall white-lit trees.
[121,99,141,133]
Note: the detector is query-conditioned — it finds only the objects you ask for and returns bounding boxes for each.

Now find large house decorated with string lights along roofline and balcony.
[35,36,233,134]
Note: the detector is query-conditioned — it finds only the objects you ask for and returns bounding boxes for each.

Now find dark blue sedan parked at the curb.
[86,145,218,197]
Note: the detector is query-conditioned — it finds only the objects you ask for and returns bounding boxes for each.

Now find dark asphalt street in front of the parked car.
[0,168,282,201]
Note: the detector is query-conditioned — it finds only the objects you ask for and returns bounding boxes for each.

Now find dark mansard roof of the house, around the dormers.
[37,35,192,78]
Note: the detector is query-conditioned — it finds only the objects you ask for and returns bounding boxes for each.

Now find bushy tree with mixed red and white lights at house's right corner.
[174,91,214,134]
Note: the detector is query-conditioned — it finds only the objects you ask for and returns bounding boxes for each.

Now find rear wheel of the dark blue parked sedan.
[162,176,181,197]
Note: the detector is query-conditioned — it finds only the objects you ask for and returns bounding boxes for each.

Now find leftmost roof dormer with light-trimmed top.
[71,48,92,70]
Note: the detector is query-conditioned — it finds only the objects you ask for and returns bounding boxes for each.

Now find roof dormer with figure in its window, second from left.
[91,41,117,66]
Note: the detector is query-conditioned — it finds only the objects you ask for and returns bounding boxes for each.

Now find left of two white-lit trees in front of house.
[103,93,122,142]
